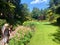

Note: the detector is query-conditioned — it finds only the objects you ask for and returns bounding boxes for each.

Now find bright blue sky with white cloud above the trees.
[21,0,49,11]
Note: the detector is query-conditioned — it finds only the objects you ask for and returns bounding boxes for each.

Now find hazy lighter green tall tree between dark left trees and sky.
[20,3,29,22]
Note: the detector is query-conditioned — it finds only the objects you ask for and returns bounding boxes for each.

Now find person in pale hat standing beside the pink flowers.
[1,23,12,45]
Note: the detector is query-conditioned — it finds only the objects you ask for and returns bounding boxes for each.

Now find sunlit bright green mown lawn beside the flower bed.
[29,22,60,45]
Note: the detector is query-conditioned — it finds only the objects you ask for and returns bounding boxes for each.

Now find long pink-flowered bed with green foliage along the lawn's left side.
[9,21,38,45]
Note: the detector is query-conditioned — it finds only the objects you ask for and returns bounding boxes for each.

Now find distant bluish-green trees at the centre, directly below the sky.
[31,7,47,20]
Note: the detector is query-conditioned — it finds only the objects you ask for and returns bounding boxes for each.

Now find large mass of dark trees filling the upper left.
[0,0,29,25]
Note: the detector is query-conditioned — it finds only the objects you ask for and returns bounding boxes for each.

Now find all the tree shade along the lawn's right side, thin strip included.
[44,23,60,44]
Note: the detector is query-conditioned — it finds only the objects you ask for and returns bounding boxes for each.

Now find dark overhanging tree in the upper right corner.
[50,0,60,22]
